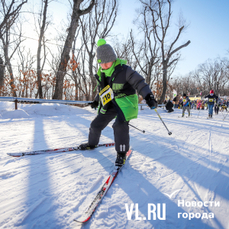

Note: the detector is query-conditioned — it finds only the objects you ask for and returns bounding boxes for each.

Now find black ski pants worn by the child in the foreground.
[88,106,130,152]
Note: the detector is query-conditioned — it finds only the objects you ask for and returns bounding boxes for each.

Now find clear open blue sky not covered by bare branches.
[112,0,229,76]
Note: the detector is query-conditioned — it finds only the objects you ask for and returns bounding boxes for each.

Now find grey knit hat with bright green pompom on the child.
[97,39,117,64]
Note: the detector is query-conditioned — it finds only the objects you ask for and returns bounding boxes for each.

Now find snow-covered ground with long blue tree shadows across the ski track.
[0,102,229,229]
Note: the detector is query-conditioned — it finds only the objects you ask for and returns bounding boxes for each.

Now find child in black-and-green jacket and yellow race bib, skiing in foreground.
[80,39,157,166]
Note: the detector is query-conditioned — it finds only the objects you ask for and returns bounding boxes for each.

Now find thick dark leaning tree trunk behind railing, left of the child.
[53,0,95,99]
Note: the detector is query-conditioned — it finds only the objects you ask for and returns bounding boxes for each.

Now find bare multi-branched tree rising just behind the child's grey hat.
[78,0,118,99]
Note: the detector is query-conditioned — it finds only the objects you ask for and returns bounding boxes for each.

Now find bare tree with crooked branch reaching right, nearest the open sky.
[139,0,190,103]
